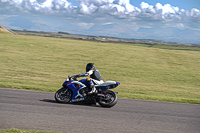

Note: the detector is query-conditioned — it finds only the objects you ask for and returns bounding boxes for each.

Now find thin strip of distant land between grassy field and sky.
[13,27,200,47]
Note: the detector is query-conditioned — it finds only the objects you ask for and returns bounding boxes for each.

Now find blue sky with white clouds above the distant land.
[0,0,200,43]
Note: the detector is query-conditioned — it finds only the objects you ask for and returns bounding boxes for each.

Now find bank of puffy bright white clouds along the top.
[0,0,200,20]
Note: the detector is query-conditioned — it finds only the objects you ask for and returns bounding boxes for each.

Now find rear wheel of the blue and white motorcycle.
[98,90,118,108]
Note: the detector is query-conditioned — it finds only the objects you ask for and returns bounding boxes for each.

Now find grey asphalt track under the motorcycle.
[0,88,200,133]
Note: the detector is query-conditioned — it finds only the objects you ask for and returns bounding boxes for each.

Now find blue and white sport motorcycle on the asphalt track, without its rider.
[55,75,120,108]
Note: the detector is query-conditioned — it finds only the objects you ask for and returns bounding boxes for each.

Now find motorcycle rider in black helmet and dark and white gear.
[78,63,104,94]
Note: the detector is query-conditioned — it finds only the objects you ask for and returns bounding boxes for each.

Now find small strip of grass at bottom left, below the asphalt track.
[0,128,58,133]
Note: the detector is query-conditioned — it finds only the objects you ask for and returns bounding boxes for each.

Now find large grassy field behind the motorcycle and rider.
[0,33,200,104]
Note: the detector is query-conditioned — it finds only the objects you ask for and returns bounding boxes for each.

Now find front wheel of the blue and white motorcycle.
[55,88,72,103]
